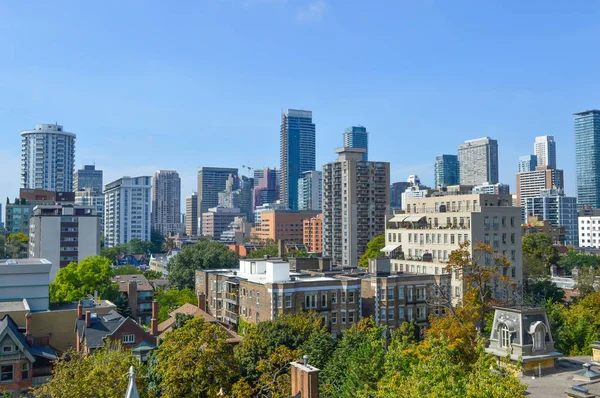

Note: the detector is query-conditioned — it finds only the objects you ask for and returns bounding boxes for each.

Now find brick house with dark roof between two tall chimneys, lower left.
[75,301,158,359]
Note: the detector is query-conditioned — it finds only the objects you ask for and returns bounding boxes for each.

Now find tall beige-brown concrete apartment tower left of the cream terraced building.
[323,148,390,267]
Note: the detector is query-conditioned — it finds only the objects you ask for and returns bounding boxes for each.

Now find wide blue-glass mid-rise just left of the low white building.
[524,188,580,246]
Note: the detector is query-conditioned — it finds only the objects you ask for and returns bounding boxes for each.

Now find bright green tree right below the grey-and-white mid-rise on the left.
[50,256,119,303]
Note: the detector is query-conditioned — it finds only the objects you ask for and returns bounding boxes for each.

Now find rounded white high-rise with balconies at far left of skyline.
[21,124,75,192]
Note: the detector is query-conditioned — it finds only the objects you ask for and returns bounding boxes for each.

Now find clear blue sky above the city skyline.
[0,0,600,205]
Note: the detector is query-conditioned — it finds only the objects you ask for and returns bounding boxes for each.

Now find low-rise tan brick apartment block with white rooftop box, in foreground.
[196,258,361,335]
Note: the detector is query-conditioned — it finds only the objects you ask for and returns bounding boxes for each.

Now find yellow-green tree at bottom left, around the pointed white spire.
[33,341,146,398]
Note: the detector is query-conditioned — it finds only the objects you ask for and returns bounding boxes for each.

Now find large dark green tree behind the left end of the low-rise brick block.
[167,239,239,289]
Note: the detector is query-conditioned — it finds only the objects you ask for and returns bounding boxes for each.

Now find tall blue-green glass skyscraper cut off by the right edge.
[575,110,600,208]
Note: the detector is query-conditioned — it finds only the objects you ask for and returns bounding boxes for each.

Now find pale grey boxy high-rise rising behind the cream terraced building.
[458,137,499,185]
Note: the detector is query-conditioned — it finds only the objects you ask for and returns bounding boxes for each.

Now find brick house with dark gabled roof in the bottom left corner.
[0,314,57,397]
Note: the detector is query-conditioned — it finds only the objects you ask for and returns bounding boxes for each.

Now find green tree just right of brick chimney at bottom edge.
[321,318,386,398]
